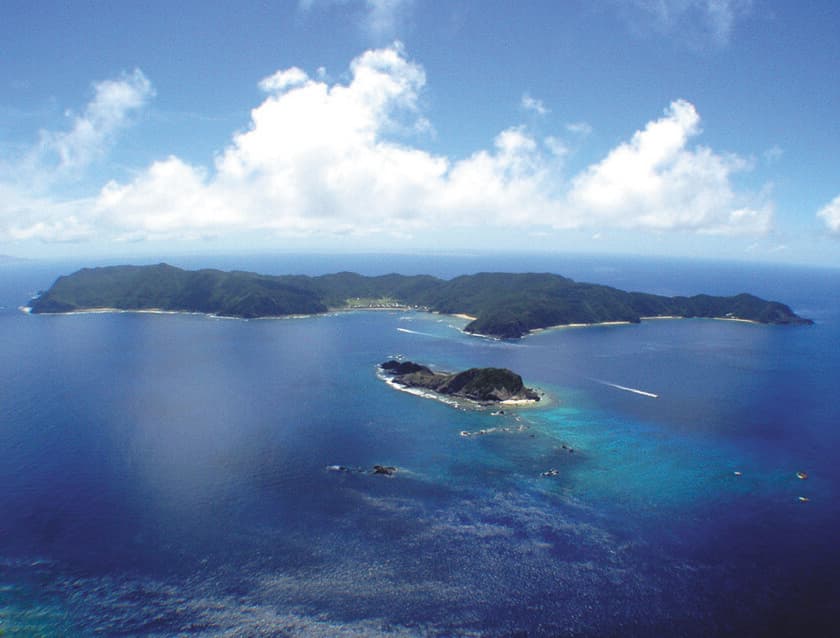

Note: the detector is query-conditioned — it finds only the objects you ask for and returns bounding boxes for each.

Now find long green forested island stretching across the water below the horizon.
[29,264,813,339]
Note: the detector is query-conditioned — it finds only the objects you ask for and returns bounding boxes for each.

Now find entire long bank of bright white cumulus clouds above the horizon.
[0,44,772,241]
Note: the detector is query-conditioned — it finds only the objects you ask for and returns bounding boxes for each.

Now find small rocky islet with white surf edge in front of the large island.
[379,359,540,404]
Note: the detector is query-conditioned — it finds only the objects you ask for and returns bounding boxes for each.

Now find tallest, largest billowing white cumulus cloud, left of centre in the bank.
[98,45,446,236]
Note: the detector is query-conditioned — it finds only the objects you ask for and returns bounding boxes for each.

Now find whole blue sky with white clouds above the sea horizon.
[0,0,840,267]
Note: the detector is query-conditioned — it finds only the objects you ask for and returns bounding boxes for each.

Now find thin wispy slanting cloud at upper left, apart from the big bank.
[38,69,154,172]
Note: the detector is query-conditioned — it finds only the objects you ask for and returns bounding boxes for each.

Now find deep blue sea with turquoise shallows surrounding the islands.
[0,255,840,637]
